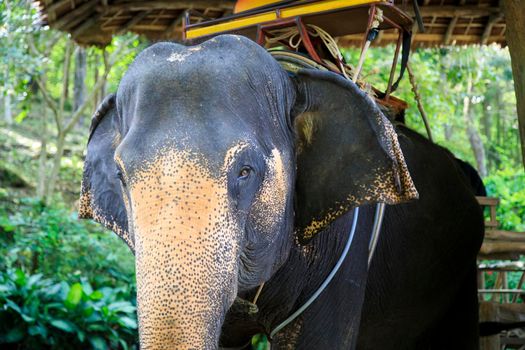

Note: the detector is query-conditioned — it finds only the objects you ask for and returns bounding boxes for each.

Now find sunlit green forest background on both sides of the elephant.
[0,0,525,349]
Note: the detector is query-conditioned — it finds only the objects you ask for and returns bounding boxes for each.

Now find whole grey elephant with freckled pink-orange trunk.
[79,35,483,349]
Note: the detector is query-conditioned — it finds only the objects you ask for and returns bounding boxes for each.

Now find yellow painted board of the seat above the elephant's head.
[186,0,388,39]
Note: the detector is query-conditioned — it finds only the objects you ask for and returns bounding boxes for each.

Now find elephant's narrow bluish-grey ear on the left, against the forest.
[78,94,134,250]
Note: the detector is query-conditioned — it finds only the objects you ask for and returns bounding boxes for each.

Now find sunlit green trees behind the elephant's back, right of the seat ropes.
[343,45,523,170]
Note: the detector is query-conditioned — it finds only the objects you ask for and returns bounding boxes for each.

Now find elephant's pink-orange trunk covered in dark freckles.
[130,151,239,349]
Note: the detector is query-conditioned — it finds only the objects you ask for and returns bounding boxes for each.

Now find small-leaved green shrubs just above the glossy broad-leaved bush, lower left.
[0,194,134,286]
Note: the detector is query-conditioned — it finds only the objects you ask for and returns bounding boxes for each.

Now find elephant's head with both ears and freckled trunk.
[80,36,417,348]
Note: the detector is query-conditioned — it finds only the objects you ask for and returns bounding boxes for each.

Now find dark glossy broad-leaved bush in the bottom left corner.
[0,269,137,350]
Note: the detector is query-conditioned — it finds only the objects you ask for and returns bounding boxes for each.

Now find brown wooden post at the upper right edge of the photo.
[503,0,525,167]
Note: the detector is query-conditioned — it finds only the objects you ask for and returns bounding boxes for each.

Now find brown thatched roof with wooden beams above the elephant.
[35,0,506,46]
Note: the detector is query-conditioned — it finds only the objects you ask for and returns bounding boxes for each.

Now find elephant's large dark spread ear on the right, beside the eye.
[292,70,418,244]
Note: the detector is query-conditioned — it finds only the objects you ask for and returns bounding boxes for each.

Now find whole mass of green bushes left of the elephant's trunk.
[0,194,137,349]
